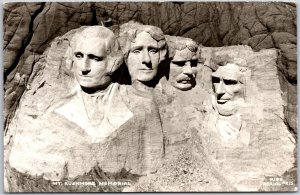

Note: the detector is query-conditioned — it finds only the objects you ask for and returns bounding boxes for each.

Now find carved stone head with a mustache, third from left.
[165,35,198,91]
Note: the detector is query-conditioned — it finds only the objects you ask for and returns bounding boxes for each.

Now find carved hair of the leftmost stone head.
[70,26,123,74]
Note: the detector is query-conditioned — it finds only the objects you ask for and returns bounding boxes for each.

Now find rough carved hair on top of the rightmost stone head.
[210,51,248,72]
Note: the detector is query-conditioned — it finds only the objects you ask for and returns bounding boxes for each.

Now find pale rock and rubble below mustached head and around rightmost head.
[120,46,297,192]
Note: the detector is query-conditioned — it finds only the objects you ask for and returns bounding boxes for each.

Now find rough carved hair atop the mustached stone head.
[165,35,199,59]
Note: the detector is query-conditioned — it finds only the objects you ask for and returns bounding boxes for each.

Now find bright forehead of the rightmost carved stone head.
[212,63,243,81]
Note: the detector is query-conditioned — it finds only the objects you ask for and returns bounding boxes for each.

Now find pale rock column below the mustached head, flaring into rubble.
[123,78,236,192]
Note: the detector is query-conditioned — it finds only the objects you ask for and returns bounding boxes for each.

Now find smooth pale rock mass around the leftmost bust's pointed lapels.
[4,27,163,192]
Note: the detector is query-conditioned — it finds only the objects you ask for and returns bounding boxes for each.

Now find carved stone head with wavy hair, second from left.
[119,21,167,85]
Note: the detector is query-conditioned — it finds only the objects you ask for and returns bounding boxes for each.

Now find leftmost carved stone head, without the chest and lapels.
[71,26,123,91]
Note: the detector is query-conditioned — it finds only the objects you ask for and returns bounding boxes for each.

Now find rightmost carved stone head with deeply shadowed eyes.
[212,52,247,116]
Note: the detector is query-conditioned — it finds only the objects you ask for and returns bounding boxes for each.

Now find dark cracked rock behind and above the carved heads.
[4,2,297,132]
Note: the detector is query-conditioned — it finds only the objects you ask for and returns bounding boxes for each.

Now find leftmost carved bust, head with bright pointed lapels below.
[55,26,132,142]
